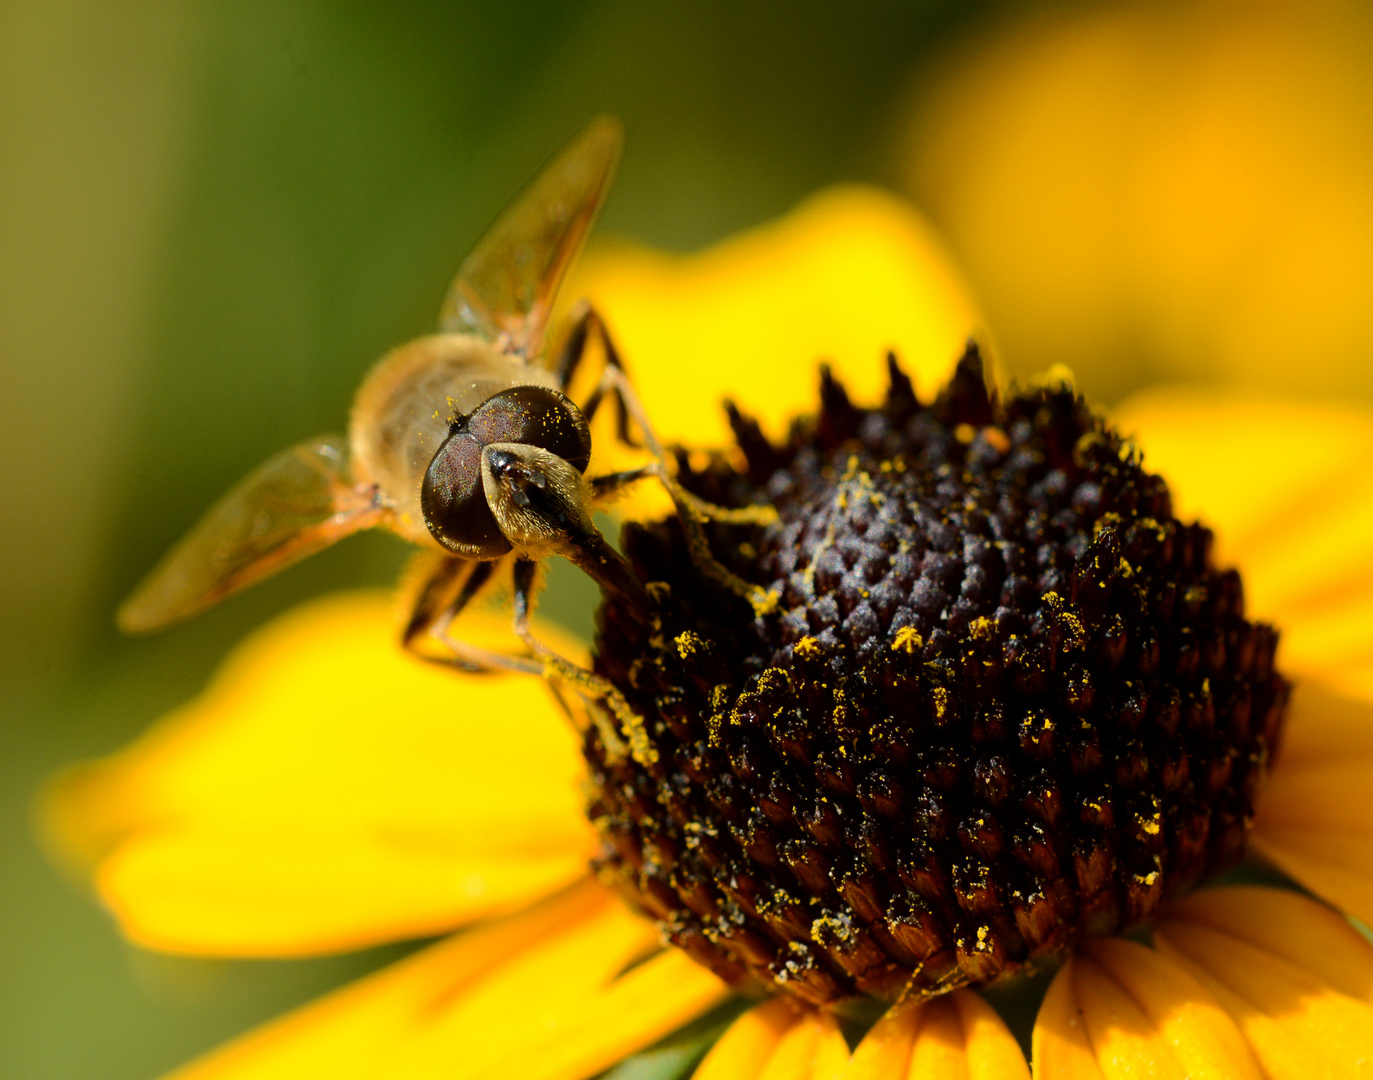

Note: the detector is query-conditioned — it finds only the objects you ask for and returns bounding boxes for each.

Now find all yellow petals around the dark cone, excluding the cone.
[43,189,1373,1080]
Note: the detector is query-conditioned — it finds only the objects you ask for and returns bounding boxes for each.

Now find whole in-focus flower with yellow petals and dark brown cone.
[37,191,1373,1080]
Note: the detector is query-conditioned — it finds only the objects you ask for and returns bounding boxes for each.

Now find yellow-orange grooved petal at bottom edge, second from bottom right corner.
[1034,939,1260,1080]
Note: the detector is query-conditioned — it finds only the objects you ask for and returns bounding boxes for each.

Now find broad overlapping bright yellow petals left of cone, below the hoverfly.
[44,594,592,955]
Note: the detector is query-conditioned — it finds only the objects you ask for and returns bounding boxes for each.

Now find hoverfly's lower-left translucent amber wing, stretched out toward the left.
[115,435,383,634]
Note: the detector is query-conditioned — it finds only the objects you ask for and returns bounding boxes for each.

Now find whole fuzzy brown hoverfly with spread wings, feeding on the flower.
[117,117,770,712]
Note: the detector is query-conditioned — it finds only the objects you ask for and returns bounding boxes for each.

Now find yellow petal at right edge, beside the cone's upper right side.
[1116,388,1373,692]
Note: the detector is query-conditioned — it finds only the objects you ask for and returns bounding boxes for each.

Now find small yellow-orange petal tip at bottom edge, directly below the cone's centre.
[844,989,1030,1080]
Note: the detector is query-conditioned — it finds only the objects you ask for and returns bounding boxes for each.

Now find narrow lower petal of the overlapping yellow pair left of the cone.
[96,825,586,956]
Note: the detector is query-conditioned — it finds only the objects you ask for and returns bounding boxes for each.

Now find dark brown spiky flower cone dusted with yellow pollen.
[584,350,1288,1003]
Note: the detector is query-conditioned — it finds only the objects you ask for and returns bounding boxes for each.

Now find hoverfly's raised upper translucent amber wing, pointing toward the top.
[439,117,625,360]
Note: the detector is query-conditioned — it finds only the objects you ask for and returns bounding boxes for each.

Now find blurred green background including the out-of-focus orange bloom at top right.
[8,0,1373,1080]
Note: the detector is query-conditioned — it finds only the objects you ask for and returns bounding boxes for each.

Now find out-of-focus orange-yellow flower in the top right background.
[902,0,1373,399]
